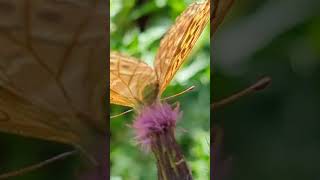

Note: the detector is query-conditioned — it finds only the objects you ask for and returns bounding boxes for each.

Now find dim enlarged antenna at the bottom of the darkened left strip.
[0,150,78,179]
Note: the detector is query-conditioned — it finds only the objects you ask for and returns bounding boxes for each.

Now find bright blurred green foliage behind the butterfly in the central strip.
[110,0,210,180]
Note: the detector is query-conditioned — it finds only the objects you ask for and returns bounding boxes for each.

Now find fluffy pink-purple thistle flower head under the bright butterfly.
[133,103,181,150]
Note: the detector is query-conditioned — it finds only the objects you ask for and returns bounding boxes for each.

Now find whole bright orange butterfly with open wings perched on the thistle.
[110,1,210,109]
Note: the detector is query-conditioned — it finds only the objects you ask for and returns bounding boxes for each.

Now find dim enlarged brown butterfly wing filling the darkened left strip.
[0,0,108,179]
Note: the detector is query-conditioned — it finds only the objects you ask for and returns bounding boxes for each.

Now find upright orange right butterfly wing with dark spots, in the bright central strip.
[155,1,210,93]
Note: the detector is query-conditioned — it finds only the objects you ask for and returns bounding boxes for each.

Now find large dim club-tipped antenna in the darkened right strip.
[211,77,271,109]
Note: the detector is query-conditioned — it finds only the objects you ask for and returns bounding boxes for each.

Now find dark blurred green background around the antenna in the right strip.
[211,0,320,180]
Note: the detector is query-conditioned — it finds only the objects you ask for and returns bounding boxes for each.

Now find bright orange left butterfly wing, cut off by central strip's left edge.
[110,52,156,107]
